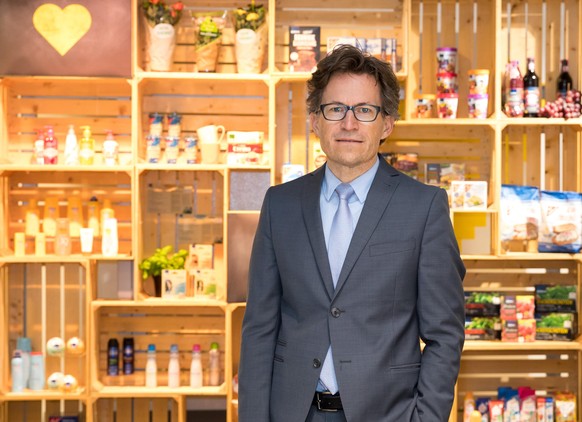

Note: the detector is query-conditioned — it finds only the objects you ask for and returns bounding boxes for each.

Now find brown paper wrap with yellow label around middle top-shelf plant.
[192,11,227,72]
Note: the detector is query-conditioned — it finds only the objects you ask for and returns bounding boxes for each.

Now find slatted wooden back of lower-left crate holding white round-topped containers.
[7,264,88,388]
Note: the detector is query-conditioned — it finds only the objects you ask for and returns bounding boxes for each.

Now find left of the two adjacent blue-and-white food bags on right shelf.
[500,185,541,241]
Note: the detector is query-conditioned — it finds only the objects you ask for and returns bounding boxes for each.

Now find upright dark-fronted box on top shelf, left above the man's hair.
[289,26,321,72]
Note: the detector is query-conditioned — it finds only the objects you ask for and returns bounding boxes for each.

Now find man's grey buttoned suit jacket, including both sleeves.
[239,157,465,422]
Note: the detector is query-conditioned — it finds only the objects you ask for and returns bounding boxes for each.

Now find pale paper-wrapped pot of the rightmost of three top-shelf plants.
[235,25,267,73]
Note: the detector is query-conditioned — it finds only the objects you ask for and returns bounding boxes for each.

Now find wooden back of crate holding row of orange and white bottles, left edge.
[6,172,133,254]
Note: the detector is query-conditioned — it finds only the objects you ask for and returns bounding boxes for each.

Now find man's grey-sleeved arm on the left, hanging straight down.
[238,192,281,422]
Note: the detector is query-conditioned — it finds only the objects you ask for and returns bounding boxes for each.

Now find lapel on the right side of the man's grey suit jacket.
[336,157,400,295]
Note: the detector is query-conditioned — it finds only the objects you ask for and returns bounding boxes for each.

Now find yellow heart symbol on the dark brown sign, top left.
[32,3,91,56]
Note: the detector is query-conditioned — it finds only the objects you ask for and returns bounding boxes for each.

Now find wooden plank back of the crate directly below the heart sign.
[2,78,132,165]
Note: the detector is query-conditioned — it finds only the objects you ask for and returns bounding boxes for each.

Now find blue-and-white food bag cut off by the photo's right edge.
[538,191,582,253]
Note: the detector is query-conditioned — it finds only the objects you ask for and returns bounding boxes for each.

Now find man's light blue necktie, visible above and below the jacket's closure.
[319,183,354,394]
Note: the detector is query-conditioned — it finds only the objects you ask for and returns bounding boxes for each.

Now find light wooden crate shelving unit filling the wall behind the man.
[0,0,582,422]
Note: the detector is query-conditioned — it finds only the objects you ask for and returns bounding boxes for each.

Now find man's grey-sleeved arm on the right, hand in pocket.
[417,189,465,422]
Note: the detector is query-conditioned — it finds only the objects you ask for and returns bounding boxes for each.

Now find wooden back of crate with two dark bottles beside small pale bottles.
[94,306,226,386]
